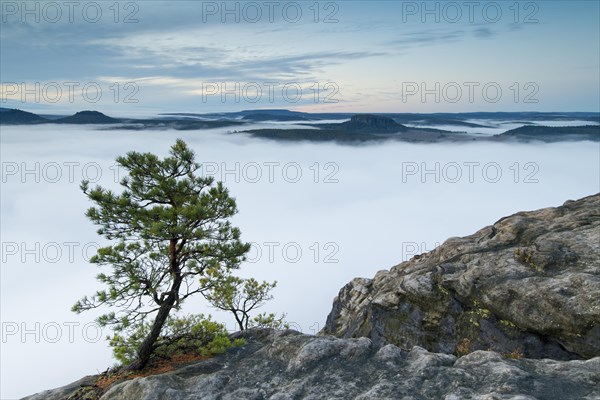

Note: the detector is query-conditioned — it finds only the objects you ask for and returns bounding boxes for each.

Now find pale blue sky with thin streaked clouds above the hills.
[0,0,600,115]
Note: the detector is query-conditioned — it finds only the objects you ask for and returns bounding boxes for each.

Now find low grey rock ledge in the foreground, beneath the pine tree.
[21,330,600,400]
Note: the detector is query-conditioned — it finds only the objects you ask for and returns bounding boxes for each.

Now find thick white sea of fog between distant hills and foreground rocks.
[0,125,600,399]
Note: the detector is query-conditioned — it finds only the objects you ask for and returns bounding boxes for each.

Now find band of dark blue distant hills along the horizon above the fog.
[0,107,600,143]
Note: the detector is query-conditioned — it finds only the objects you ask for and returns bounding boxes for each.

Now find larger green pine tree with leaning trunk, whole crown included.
[73,139,250,369]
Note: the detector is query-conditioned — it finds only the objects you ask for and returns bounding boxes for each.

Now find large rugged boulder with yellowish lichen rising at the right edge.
[322,195,600,360]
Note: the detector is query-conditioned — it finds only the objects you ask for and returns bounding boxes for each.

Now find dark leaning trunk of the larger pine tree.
[127,240,182,371]
